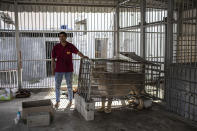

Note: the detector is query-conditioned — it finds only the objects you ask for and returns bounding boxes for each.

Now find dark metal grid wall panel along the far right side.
[165,0,197,121]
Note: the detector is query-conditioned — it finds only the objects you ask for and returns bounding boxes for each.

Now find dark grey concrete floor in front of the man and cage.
[0,92,197,131]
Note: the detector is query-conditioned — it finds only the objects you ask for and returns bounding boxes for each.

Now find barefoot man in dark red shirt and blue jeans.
[52,32,88,108]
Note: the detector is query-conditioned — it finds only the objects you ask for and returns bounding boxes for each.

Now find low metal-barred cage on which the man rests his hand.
[78,52,160,109]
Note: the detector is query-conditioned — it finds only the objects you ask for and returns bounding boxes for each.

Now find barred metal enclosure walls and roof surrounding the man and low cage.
[0,0,197,121]
